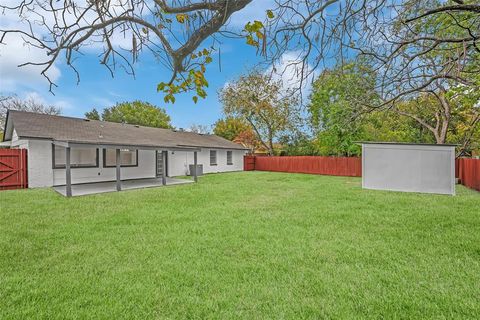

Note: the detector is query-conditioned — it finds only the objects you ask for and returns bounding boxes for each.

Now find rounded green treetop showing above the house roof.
[85,100,172,128]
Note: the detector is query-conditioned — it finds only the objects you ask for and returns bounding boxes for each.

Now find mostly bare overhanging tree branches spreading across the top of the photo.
[0,0,480,105]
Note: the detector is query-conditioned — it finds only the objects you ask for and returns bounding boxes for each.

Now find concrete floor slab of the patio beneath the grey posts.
[53,178,193,197]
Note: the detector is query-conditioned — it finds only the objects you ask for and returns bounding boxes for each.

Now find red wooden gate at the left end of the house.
[0,149,28,190]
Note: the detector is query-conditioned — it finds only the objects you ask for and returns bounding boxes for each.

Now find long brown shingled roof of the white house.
[4,110,245,150]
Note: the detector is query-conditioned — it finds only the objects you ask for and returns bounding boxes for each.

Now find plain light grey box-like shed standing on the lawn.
[361,142,455,195]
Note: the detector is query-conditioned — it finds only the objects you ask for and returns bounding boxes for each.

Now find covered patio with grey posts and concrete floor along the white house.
[53,141,201,197]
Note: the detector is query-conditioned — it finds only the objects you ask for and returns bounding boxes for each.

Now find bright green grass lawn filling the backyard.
[0,172,480,319]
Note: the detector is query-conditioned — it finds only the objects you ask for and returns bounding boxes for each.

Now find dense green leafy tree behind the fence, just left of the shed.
[307,61,377,156]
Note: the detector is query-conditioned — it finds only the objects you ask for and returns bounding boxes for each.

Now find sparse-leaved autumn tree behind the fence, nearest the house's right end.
[219,71,299,155]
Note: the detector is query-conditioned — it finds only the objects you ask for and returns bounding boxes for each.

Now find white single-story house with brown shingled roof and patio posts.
[2,110,248,196]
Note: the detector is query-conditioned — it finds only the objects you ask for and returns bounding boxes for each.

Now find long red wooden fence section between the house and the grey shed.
[244,156,362,177]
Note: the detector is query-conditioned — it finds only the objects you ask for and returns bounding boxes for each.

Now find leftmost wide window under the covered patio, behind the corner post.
[52,145,98,169]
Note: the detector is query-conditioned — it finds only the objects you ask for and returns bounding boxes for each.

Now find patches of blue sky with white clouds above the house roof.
[0,1,280,128]
